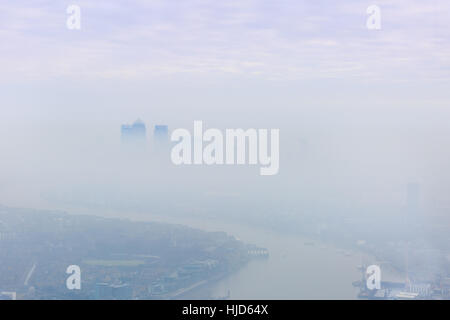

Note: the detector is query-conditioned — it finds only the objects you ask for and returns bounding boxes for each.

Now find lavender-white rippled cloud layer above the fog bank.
[0,0,450,81]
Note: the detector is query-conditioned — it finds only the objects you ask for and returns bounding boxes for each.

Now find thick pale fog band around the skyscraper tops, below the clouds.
[1,80,449,215]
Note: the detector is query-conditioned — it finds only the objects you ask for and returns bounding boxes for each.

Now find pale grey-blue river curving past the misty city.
[107,213,370,299]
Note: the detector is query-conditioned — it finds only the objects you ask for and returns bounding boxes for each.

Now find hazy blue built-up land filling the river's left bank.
[0,208,264,300]
